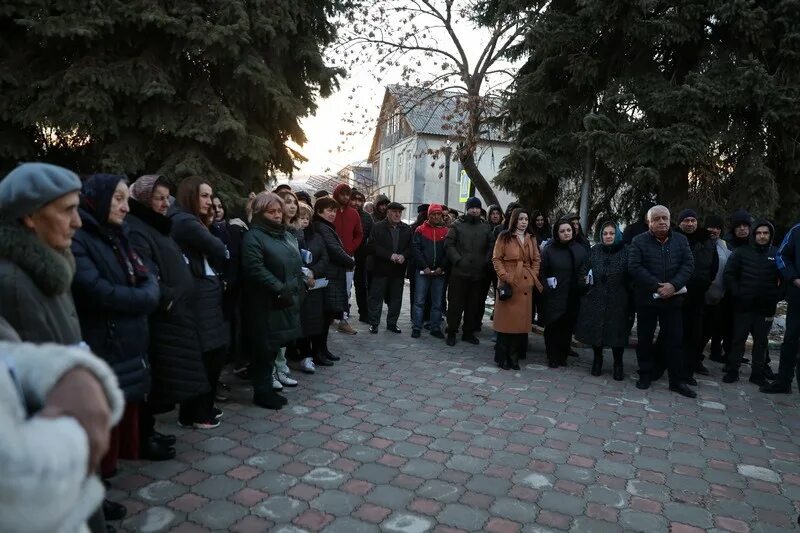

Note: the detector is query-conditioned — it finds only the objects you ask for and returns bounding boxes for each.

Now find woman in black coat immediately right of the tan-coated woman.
[539,219,587,368]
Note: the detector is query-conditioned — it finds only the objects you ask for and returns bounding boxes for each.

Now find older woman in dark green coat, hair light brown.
[242,192,305,409]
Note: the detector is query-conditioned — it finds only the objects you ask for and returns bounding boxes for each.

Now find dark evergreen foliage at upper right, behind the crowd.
[483,0,800,226]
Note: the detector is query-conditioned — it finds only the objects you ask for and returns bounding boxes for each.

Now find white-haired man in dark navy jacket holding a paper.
[628,205,697,398]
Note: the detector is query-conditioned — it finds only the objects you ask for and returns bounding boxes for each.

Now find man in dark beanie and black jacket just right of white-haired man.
[678,209,719,378]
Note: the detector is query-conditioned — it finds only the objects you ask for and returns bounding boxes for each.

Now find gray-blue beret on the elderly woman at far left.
[0,163,81,220]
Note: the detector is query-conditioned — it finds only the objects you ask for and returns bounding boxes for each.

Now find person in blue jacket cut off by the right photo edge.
[760,218,800,394]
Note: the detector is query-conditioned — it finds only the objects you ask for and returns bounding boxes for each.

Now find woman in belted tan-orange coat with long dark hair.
[492,209,541,370]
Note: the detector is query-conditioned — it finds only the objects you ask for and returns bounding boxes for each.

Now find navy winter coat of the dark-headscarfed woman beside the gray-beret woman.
[72,209,160,402]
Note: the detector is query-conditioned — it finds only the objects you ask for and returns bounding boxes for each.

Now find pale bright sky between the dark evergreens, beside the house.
[296,0,520,174]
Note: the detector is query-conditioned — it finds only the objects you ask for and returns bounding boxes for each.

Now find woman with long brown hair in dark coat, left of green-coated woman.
[169,176,230,429]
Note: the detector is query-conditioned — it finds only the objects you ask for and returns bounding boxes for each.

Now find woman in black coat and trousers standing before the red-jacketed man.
[313,197,356,361]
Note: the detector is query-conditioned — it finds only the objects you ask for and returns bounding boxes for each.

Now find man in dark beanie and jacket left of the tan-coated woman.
[445,197,494,346]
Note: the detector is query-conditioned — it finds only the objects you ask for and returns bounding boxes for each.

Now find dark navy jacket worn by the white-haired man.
[628,230,694,306]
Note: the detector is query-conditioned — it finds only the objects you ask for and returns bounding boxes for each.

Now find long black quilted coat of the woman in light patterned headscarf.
[126,200,209,404]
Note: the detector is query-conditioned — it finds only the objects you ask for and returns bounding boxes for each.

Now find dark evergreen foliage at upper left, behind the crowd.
[0,0,344,193]
